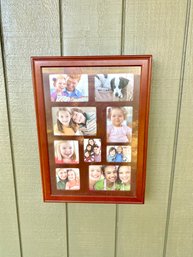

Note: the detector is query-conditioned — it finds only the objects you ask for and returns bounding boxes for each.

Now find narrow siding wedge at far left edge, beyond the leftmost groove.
[0,38,20,257]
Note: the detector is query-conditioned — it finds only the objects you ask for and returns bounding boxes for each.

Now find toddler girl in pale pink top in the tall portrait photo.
[107,107,132,143]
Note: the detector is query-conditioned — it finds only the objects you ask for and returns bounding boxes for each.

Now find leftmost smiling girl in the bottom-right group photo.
[89,165,104,190]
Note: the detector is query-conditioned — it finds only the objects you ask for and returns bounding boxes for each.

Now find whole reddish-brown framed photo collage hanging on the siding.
[31,55,152,203]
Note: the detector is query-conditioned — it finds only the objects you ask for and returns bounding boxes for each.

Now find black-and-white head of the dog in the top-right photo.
[111,77,129,98]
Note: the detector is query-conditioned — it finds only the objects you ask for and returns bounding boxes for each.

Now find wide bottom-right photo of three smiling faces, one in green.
[89,165,131,191]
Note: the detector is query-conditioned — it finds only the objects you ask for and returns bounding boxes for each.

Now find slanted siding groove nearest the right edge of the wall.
[163,0,191,257]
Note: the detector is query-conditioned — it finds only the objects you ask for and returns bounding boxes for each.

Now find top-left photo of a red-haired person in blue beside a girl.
[49,74,88,102]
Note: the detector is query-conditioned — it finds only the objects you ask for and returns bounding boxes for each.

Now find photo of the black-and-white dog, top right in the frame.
[95,74,133,101]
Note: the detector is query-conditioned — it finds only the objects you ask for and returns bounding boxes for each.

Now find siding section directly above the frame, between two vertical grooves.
[62,0,122,55]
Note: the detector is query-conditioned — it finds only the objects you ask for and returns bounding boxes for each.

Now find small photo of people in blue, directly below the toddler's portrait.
[107,145,131,162]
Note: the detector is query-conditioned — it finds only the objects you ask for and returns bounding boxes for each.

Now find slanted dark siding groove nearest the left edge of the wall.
[0,2,23,257]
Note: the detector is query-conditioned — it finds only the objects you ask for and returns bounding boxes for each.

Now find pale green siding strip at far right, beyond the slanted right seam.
[166,2,193,257]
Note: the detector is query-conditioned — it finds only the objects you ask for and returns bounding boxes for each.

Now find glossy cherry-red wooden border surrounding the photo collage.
[31,55,152,203]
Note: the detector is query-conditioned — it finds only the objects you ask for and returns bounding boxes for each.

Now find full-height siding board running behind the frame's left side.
[1,0,66,257]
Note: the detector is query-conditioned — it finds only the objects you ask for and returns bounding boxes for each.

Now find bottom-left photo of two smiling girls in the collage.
[56,168,80,190]
